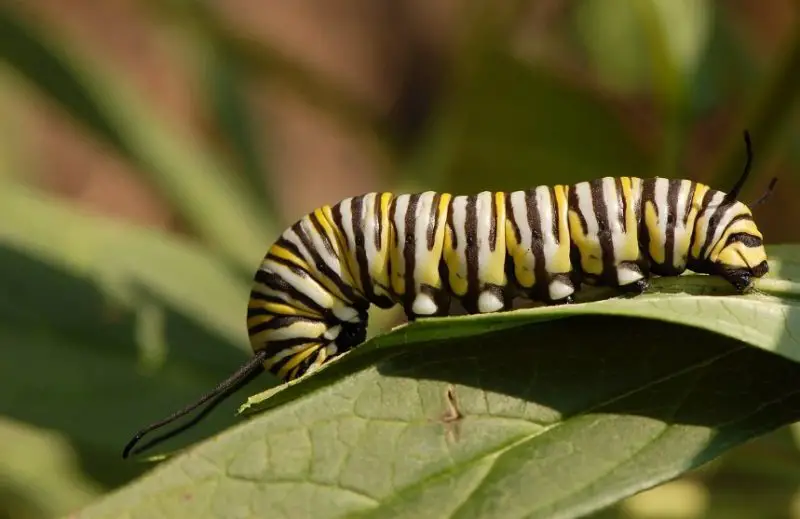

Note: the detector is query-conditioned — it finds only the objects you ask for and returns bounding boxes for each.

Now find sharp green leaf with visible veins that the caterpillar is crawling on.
[72,247,800,518]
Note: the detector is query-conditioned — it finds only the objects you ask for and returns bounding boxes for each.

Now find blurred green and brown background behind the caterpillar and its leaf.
[0,0,800,519]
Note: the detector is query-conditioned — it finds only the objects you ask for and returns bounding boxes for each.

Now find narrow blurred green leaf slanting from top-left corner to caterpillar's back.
[0,7,276,274]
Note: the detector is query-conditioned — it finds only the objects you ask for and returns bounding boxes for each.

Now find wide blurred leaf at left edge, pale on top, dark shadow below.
[0,184,275,472]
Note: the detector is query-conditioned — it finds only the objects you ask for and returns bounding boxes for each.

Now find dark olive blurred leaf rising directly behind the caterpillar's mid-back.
[406,48,648,193]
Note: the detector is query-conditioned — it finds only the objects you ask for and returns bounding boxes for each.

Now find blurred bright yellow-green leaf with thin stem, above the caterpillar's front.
[577,0,713,177]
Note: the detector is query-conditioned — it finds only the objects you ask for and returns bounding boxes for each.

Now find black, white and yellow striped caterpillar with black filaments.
[123,132,776,457]
